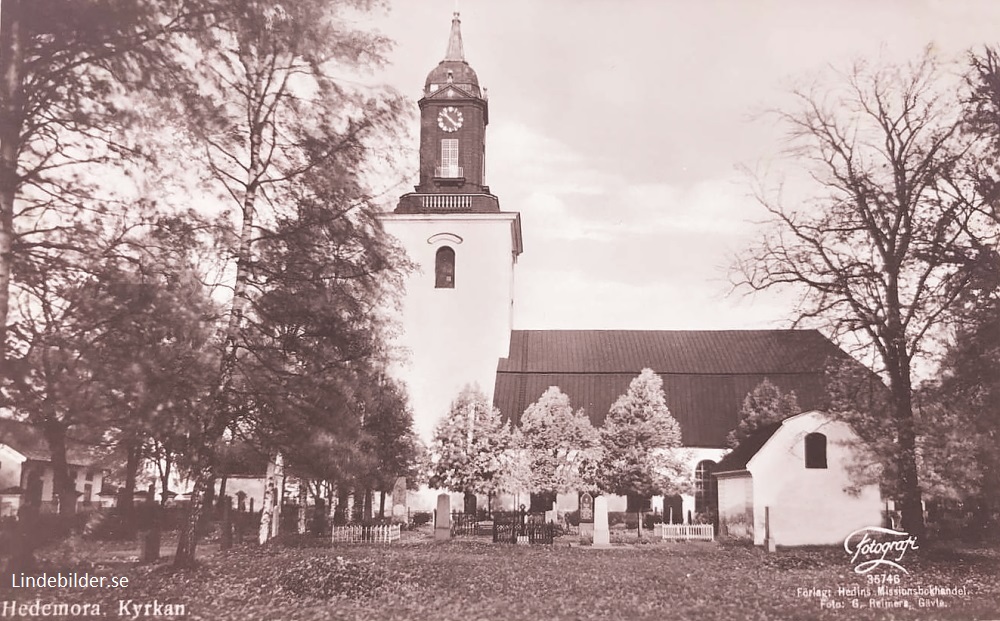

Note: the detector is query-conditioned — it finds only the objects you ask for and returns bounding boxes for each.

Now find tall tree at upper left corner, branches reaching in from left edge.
[0,0,203,360]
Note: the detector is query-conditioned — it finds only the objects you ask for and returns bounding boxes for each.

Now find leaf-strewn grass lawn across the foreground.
[0,536,1000,621]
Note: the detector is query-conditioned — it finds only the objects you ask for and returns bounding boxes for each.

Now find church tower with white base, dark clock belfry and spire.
[382,13,521,438]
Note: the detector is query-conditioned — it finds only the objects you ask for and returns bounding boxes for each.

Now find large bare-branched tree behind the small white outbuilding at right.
[735,52,996,536]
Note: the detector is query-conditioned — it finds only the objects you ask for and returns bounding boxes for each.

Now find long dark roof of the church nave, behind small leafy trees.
[493,330,847,448]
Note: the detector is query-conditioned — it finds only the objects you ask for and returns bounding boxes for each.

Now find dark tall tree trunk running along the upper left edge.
[0,0,27,361]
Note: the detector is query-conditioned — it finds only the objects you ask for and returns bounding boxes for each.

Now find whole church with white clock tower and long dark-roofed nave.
[382,13,880,519]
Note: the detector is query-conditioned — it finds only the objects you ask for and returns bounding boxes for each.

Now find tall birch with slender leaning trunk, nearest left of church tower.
[164,0,410,566]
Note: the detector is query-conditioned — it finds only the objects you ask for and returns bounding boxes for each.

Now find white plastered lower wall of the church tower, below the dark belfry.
[382,213,516,438]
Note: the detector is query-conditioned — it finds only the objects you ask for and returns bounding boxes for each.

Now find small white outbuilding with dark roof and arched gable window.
[715,411,883,546]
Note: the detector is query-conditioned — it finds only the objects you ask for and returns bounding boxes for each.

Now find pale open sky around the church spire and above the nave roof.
[370,0,1000,329]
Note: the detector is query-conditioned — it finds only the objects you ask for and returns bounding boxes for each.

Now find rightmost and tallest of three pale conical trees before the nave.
[599,369,691,516]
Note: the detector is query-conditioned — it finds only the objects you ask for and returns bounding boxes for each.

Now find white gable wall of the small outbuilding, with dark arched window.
[752,412,882,546]
